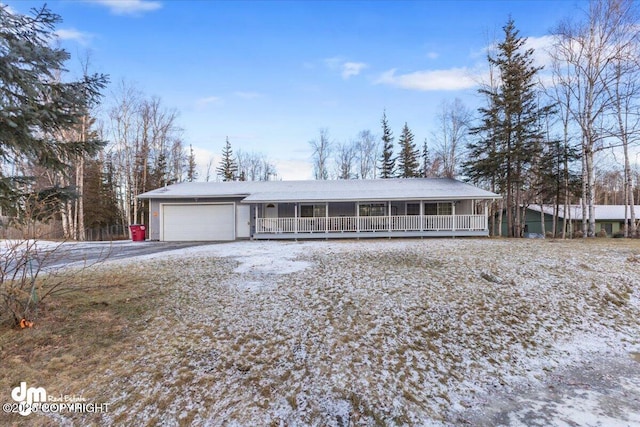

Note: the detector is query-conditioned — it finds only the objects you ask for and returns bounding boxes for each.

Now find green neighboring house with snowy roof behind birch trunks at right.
[516,205,640,237]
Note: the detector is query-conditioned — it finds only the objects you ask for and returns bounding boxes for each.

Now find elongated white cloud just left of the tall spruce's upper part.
[376,67,481,91]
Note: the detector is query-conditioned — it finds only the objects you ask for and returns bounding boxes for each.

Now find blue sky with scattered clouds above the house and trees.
[3,0,584,179]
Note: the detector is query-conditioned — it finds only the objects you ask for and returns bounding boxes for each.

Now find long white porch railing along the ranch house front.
[256,215,487,234]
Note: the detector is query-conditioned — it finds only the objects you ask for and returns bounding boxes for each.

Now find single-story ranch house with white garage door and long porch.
[138,178,500,241]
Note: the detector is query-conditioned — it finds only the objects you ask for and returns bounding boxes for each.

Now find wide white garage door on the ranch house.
[162,203,236,241]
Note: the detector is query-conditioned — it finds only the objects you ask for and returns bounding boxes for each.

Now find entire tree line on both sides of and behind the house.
[0,0,640,240]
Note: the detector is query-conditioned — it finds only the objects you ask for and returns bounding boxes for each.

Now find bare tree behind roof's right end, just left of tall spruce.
[433,98,471,178]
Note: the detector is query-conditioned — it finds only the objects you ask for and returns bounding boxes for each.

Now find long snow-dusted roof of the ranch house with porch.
[138,178,500,203]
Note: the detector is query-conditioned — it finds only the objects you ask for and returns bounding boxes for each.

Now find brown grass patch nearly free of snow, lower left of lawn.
[0,267,168,426]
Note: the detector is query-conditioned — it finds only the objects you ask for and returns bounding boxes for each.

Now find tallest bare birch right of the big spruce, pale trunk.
[552,0,637,237]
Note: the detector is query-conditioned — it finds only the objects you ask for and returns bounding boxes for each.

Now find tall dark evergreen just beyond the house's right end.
[465,19,551,237]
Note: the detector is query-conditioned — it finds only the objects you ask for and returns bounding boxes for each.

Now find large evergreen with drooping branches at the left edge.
[0,5,107,206]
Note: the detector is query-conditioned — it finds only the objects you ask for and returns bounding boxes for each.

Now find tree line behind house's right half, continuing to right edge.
[310,0,640,241]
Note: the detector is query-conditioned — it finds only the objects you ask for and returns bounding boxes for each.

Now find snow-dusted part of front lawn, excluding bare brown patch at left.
[63,239,640,426]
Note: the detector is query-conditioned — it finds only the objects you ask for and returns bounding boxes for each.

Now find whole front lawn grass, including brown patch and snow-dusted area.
[0,239,640,425]
